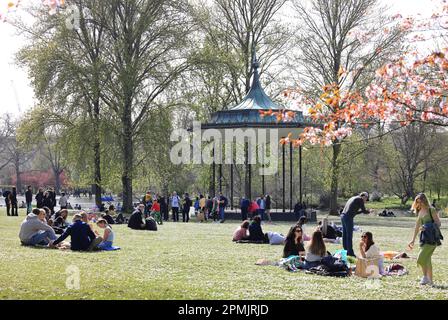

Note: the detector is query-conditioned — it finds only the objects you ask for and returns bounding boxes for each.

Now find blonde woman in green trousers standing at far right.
[408,193,441,285]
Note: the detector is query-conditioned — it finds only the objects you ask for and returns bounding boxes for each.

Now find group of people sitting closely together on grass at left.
[19,208,119,251]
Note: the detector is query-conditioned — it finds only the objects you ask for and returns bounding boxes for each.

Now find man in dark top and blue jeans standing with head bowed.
[341,192,370,257]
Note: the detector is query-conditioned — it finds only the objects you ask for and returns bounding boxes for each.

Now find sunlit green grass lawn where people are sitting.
[0,209,448,300]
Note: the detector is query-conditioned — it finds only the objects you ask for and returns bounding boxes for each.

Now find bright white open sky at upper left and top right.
[0,0,435,117]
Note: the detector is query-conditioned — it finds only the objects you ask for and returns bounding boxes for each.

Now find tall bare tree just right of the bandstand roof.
[294,0,403,214]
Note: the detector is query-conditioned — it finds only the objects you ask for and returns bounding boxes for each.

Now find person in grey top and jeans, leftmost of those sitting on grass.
[19,209,57,246]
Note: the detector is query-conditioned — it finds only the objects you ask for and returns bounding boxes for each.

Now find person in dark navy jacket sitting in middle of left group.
[50,214,103,251]
